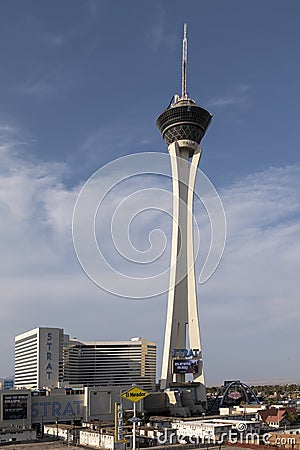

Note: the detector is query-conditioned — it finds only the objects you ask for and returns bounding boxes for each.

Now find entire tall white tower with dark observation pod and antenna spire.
[157,24,212,406]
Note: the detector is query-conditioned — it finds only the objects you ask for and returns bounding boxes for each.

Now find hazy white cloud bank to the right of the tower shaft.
[199,167,300,382]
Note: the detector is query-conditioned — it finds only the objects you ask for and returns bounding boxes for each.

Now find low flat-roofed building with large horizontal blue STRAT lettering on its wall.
[0,385,139,429]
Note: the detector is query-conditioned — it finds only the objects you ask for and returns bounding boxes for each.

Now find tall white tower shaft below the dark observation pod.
[161,142,206,402]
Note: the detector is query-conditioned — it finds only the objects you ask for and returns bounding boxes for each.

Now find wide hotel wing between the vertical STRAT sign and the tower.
[64,338,156,391]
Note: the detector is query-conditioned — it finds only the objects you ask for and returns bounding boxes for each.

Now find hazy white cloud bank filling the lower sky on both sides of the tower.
[0,125,300,384]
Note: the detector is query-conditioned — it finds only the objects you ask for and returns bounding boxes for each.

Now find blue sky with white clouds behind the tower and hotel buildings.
[0,0,300,385]
